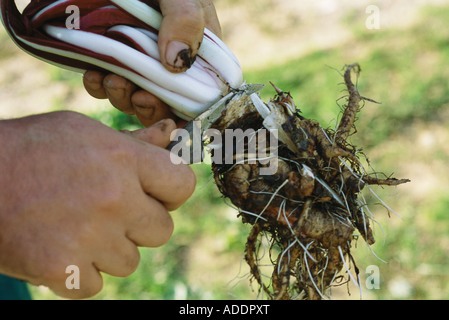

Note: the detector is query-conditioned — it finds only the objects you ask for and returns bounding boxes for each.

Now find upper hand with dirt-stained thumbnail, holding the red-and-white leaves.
[83,0,221,126]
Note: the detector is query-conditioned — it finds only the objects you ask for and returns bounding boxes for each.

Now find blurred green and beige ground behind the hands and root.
[0,0,449,299]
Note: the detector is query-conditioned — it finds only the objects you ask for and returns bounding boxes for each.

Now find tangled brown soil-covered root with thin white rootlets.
[212,64,409,299]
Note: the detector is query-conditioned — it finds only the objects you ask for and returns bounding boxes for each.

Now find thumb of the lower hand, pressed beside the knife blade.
[122,119,177,148]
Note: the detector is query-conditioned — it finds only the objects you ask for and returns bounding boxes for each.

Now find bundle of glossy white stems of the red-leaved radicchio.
[5,0,243,120]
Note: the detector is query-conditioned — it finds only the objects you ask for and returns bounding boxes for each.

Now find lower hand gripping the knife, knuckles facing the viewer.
[0,112,195,298]
